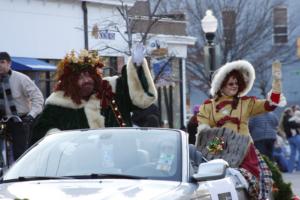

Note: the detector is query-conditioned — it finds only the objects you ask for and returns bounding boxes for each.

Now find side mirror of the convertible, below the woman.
[193,159,229,181]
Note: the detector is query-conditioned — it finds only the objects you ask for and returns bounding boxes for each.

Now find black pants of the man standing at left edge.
[7,120,30,160]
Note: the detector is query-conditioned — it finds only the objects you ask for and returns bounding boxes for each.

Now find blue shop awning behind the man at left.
[11,57,56,71]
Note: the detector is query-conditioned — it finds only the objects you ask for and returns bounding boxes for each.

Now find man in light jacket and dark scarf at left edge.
[0,52,44,159]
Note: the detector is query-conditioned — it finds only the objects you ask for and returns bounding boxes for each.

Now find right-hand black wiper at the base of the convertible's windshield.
[71,173,147,179]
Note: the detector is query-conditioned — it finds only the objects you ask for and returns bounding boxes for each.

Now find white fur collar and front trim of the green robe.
[46,91,105,128]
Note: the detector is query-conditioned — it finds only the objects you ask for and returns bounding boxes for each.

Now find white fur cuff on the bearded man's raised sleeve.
[127,57,157,108]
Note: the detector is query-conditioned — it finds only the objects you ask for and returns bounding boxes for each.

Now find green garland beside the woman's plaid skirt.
[262,155,293,200]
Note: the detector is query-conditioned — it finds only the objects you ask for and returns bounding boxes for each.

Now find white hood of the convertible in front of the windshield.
[0,179,181,200]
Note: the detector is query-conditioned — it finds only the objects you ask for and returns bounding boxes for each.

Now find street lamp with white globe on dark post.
[201,10,218,72]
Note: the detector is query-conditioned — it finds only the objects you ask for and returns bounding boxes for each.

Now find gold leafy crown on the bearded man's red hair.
[57,49,103,78]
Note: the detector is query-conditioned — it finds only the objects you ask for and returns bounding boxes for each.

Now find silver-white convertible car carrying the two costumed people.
[0,128,247,200]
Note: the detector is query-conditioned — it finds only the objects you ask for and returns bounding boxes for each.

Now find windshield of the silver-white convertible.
[3,128,182,181]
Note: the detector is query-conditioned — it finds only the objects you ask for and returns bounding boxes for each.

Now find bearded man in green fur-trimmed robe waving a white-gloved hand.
[31,45,157,144]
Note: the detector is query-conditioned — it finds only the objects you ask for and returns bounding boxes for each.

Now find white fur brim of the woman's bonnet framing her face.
[210,60,255,97]
